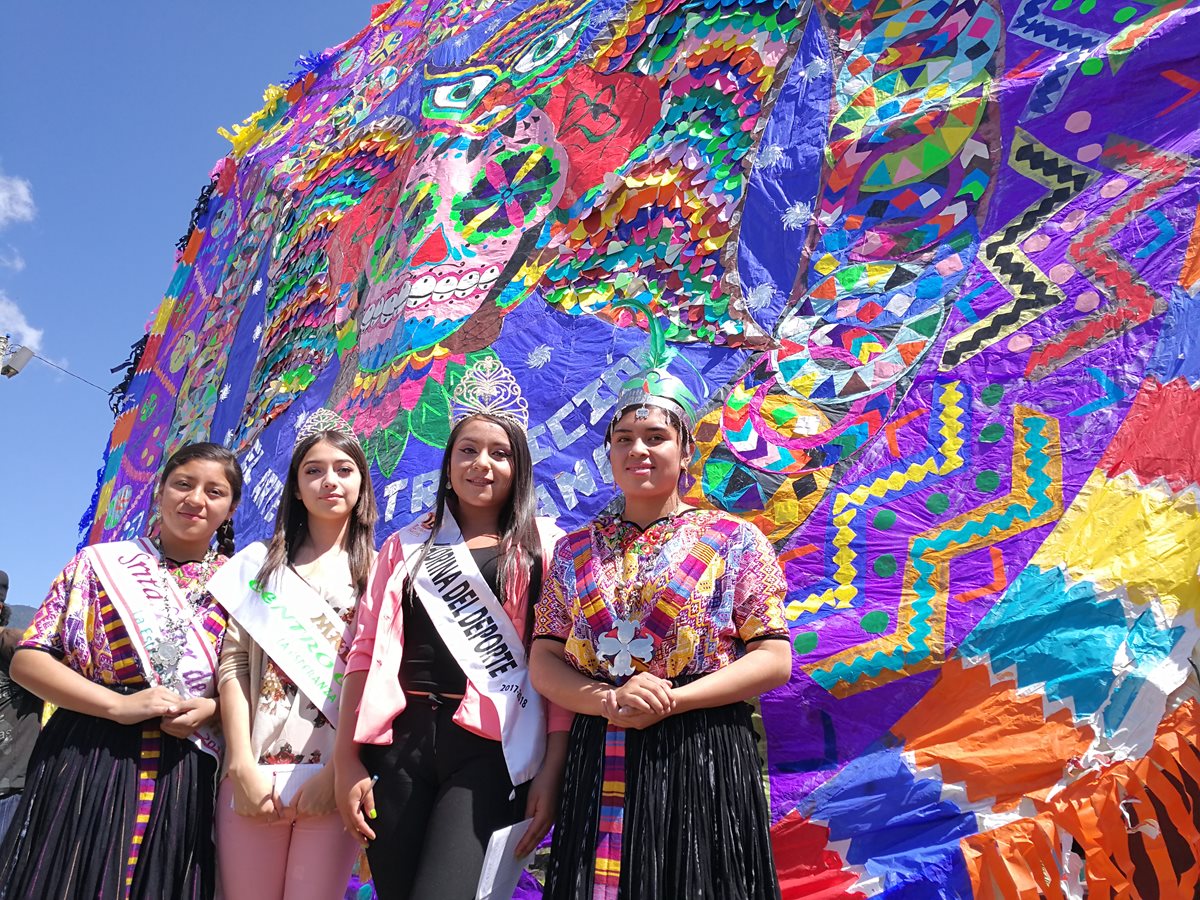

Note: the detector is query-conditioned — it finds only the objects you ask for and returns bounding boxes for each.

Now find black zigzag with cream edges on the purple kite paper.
[940,128,1098,372]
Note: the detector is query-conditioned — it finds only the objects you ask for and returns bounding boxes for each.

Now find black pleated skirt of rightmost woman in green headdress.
[545,703,779,900]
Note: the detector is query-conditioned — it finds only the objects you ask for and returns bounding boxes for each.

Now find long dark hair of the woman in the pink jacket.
[409,413,541,640]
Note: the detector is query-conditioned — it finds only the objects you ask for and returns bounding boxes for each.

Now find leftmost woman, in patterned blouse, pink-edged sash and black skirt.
[0,443,241,900]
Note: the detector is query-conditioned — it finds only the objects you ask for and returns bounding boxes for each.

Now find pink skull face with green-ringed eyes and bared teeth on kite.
[359,2,600,372]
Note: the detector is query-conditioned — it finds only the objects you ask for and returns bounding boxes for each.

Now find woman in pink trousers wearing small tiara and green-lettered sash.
[211,409,377,900]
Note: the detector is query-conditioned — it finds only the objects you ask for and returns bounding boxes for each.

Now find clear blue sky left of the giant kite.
[0,0,371,606]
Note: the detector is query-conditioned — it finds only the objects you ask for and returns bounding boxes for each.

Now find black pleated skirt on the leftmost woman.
[0,709,217,900]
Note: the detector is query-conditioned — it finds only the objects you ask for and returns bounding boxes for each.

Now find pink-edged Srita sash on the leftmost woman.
[88,538,221,760]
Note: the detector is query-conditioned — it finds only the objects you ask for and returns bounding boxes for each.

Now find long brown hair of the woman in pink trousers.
[258,431,379,595]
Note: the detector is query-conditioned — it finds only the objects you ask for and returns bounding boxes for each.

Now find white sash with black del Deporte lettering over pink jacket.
[401,510,546,785]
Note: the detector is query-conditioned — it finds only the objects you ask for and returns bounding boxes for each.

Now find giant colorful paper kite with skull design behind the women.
[84,0,1200,900]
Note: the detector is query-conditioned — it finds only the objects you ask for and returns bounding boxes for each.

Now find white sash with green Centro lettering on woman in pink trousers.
[209,542,349,728]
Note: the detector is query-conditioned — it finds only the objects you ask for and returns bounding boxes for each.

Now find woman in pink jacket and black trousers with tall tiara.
[335,360,569,900]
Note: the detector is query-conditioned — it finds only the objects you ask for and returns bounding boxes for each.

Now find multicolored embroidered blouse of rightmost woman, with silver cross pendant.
[534,510,787,683]
